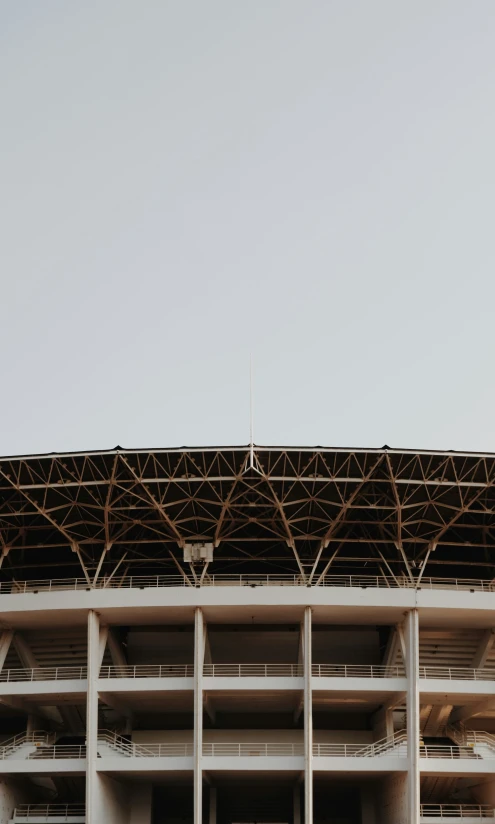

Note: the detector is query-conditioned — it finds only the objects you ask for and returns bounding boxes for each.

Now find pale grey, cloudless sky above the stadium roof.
[0,0,495,455]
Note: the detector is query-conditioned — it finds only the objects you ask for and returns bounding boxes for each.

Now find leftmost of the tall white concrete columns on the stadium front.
[86,610,101,824]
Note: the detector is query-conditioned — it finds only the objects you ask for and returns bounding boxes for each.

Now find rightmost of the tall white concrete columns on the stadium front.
[404,609,420,824]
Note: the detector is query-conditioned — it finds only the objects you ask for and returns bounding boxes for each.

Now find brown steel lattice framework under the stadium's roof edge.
[0,447,495,583]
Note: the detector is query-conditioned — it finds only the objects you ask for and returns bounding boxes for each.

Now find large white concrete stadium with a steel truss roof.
[0,445,495,824]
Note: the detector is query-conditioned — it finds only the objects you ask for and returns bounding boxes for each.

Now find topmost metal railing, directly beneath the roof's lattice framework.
[0,574,495,595]
